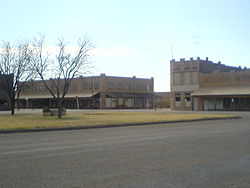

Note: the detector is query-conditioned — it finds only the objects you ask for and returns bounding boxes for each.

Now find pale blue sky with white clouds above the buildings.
[0,0,250,91]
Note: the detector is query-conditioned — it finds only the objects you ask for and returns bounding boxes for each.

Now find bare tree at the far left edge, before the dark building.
[0,41,33,115]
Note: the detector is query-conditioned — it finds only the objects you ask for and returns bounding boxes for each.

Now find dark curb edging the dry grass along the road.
[0,116,242,134]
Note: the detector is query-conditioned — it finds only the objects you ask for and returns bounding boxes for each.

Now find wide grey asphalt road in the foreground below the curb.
[0,113,250,188]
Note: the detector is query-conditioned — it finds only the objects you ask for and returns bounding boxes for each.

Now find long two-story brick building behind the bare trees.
[19,74,154,109]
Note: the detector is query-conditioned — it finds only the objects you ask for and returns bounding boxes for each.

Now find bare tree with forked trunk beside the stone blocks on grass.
[33,37,92,118]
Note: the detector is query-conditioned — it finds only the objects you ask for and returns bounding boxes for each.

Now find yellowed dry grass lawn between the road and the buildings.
[0,111,238,130]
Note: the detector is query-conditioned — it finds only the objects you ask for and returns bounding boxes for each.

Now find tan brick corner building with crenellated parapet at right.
[170,57,250,111]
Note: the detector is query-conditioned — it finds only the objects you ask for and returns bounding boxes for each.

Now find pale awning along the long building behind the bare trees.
[19,93,96,99]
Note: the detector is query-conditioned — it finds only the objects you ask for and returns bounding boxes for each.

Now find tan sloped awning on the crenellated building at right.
[191,86,250,96]
